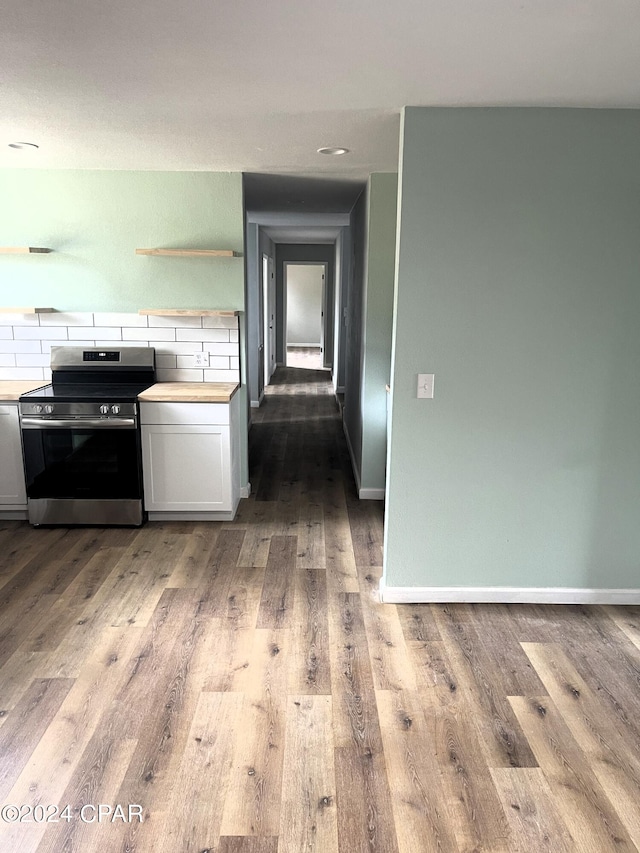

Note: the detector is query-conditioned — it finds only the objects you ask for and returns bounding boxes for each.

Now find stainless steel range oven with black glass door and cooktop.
[19,347,155,526]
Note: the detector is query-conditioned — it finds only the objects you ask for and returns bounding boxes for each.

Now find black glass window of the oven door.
[22,427,141,500]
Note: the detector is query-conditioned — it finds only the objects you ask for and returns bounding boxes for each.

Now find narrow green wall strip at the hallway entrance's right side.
[360,173,398,491]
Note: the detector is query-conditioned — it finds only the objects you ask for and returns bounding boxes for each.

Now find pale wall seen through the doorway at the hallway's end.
[285,264,324,346]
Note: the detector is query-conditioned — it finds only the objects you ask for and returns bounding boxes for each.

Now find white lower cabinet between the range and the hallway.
[140,394,240,521]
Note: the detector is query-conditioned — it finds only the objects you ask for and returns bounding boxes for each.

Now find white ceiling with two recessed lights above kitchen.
[0,0,640,185]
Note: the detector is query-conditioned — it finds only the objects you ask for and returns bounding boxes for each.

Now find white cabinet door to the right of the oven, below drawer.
[142,424,232,512]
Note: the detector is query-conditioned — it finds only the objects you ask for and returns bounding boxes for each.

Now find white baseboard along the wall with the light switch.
[379,578,640,604]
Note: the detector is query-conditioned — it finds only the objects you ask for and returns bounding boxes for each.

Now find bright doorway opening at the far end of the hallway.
[284,262,327,370]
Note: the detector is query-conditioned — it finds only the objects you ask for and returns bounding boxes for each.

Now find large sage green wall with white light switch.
[385,108,640,588]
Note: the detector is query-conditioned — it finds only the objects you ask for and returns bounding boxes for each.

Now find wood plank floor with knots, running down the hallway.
[0,368,640,853]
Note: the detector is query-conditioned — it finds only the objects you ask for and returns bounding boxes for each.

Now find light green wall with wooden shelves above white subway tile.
[0,169,244,311]
